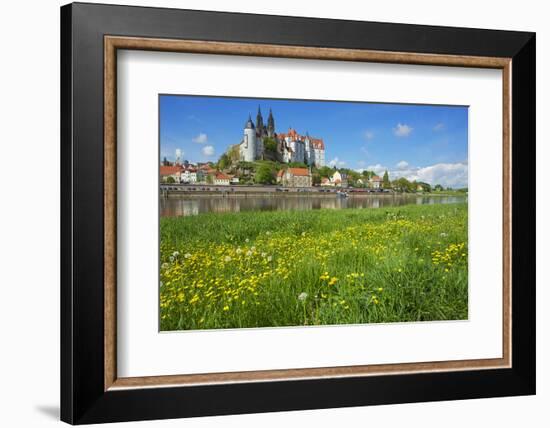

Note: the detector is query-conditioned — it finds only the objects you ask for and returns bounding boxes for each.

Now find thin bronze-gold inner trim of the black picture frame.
[104,36,511,390]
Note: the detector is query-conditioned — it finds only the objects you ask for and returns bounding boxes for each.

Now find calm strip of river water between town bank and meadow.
[160,195,466,217]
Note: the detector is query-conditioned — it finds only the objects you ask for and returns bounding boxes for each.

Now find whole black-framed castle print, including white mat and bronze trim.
[61,3,535,424]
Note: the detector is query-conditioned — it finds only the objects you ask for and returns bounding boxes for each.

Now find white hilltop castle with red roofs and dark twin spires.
[239,106,325,168]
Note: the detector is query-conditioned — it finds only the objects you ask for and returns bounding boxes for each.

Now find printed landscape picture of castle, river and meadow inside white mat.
[159,94,470,331]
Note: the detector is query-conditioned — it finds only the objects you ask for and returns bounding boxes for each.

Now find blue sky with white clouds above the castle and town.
[160,95,468,187]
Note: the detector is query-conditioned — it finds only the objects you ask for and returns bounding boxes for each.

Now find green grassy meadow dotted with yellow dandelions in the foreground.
[160,203,468,331]
